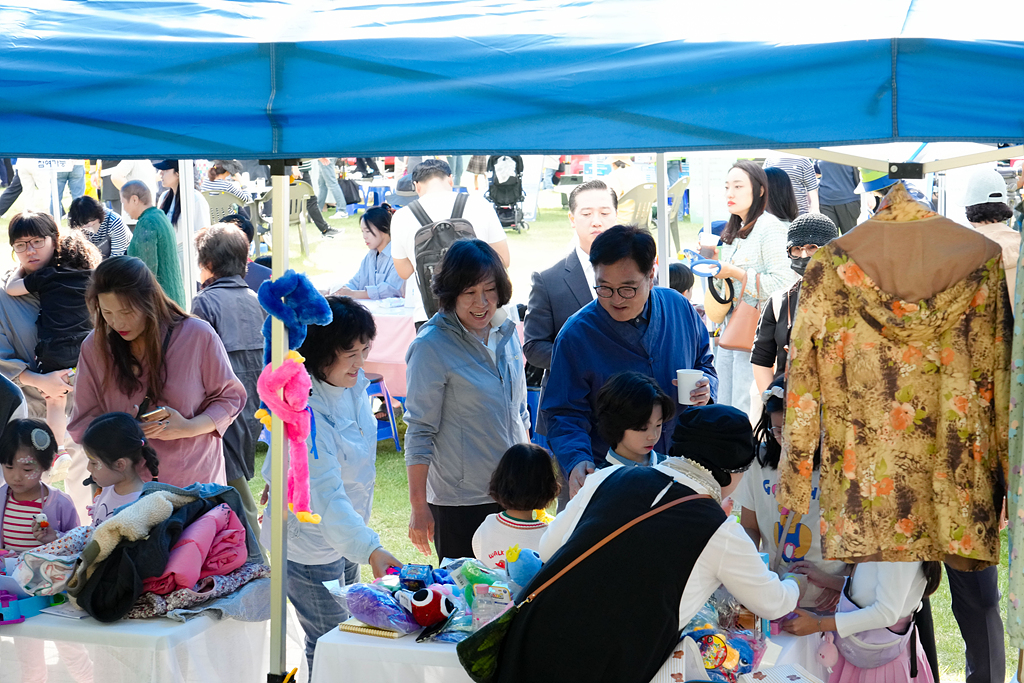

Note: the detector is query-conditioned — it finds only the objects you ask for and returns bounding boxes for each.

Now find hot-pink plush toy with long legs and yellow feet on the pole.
[256,351,321,524]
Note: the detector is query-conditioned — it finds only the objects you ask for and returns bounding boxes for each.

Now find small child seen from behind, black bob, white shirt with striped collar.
[473,443,559,568]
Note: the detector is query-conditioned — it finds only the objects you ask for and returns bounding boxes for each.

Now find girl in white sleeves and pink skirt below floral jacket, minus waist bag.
[782,562,942,683]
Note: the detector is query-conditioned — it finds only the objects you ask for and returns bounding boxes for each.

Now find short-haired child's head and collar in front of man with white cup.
[597,373,676,469]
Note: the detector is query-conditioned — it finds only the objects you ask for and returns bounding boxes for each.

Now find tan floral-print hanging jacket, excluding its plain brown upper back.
[777,245,1013,568]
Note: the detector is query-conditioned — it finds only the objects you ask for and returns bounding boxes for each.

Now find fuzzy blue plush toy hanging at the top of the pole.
[257,270,334,365]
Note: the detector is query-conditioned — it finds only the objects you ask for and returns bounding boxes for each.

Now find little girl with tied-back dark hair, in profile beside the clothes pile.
[82,413,160,526]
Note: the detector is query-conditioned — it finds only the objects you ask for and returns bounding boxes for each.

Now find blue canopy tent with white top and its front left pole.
[0,0,1024,674]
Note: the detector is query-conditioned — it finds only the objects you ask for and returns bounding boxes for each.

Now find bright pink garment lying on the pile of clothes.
[142,504,245,595]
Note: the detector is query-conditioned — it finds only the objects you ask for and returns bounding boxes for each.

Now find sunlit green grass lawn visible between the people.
[6,187,999,680]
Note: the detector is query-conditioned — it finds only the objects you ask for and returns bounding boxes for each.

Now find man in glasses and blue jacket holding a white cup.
[541,225,718,496]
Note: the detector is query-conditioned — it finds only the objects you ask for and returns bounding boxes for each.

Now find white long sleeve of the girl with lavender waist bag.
[836,562,928,638]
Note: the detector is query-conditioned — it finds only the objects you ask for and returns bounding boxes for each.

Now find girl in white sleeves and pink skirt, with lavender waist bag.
[782,562,942,683]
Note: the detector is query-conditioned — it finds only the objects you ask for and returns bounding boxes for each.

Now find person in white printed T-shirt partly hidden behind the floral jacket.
[732,376,847,609]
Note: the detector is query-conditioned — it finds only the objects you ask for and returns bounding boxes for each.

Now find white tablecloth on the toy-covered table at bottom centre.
[309,629,828,683]
